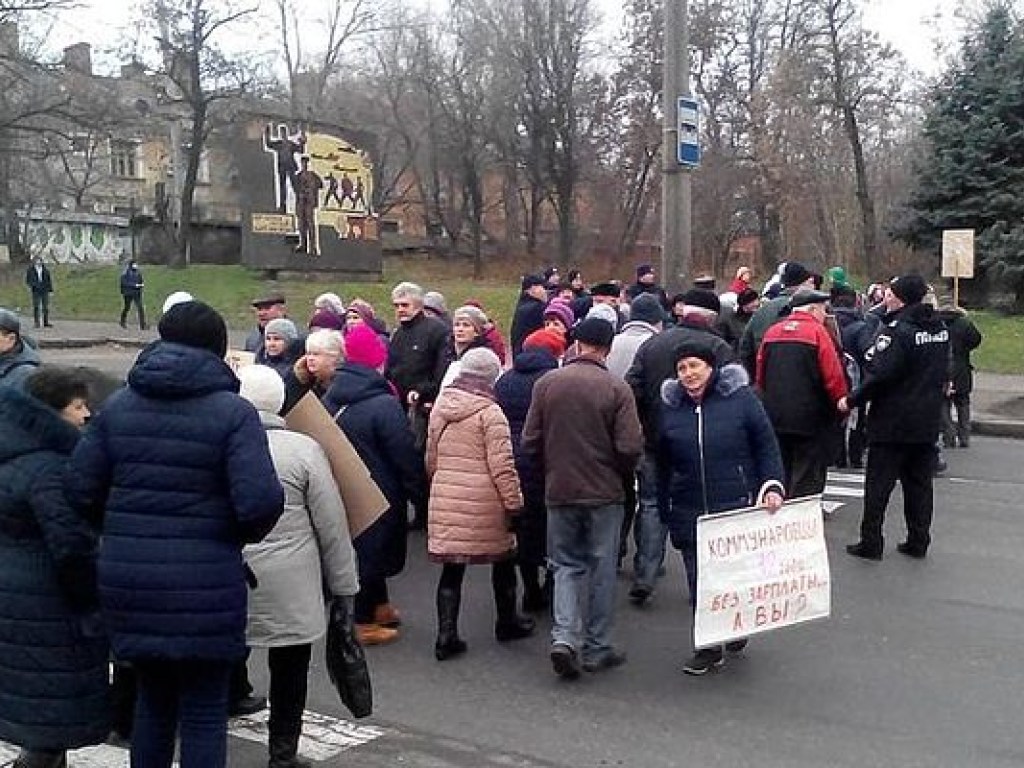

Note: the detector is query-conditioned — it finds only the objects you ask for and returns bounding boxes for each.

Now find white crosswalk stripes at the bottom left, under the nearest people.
[0,710,384,768]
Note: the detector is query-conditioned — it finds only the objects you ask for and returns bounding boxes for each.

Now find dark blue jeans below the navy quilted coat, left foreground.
[131,659,232,768]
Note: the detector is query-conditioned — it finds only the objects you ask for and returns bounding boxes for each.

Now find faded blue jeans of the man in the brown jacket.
[548,504,623,658]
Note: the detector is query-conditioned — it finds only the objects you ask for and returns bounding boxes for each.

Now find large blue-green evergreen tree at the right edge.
[894,2,1024,311]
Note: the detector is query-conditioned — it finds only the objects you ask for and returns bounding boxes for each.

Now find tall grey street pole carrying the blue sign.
[662,0,692,291]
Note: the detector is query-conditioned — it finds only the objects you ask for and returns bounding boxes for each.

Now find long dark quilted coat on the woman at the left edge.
[0,387,110,752]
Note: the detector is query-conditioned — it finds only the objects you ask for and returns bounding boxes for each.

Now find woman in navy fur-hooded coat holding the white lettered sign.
[657,341,784,675]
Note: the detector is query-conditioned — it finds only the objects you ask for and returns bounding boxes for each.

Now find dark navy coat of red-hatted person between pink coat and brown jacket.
[495,348,558,565]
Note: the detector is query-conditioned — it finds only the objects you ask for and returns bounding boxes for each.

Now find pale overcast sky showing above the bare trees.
[49,0,982,74]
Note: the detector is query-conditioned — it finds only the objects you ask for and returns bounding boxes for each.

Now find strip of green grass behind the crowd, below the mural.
[0,258,519,332]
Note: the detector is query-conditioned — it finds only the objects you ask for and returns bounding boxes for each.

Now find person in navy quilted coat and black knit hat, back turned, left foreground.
[66,301,284,768]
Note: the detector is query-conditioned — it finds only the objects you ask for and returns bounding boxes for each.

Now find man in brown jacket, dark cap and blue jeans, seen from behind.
[522,317,643,679]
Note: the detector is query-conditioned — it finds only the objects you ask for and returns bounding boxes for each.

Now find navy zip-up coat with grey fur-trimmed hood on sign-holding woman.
[657,364,783,547]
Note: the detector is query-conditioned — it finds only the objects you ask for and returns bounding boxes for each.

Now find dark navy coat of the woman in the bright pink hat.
[324,362,427,581]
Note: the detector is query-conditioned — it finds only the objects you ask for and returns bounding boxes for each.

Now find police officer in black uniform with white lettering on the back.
[840,274,949,560]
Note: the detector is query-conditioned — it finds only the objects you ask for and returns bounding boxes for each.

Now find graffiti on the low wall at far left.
[25,221,131,264]
